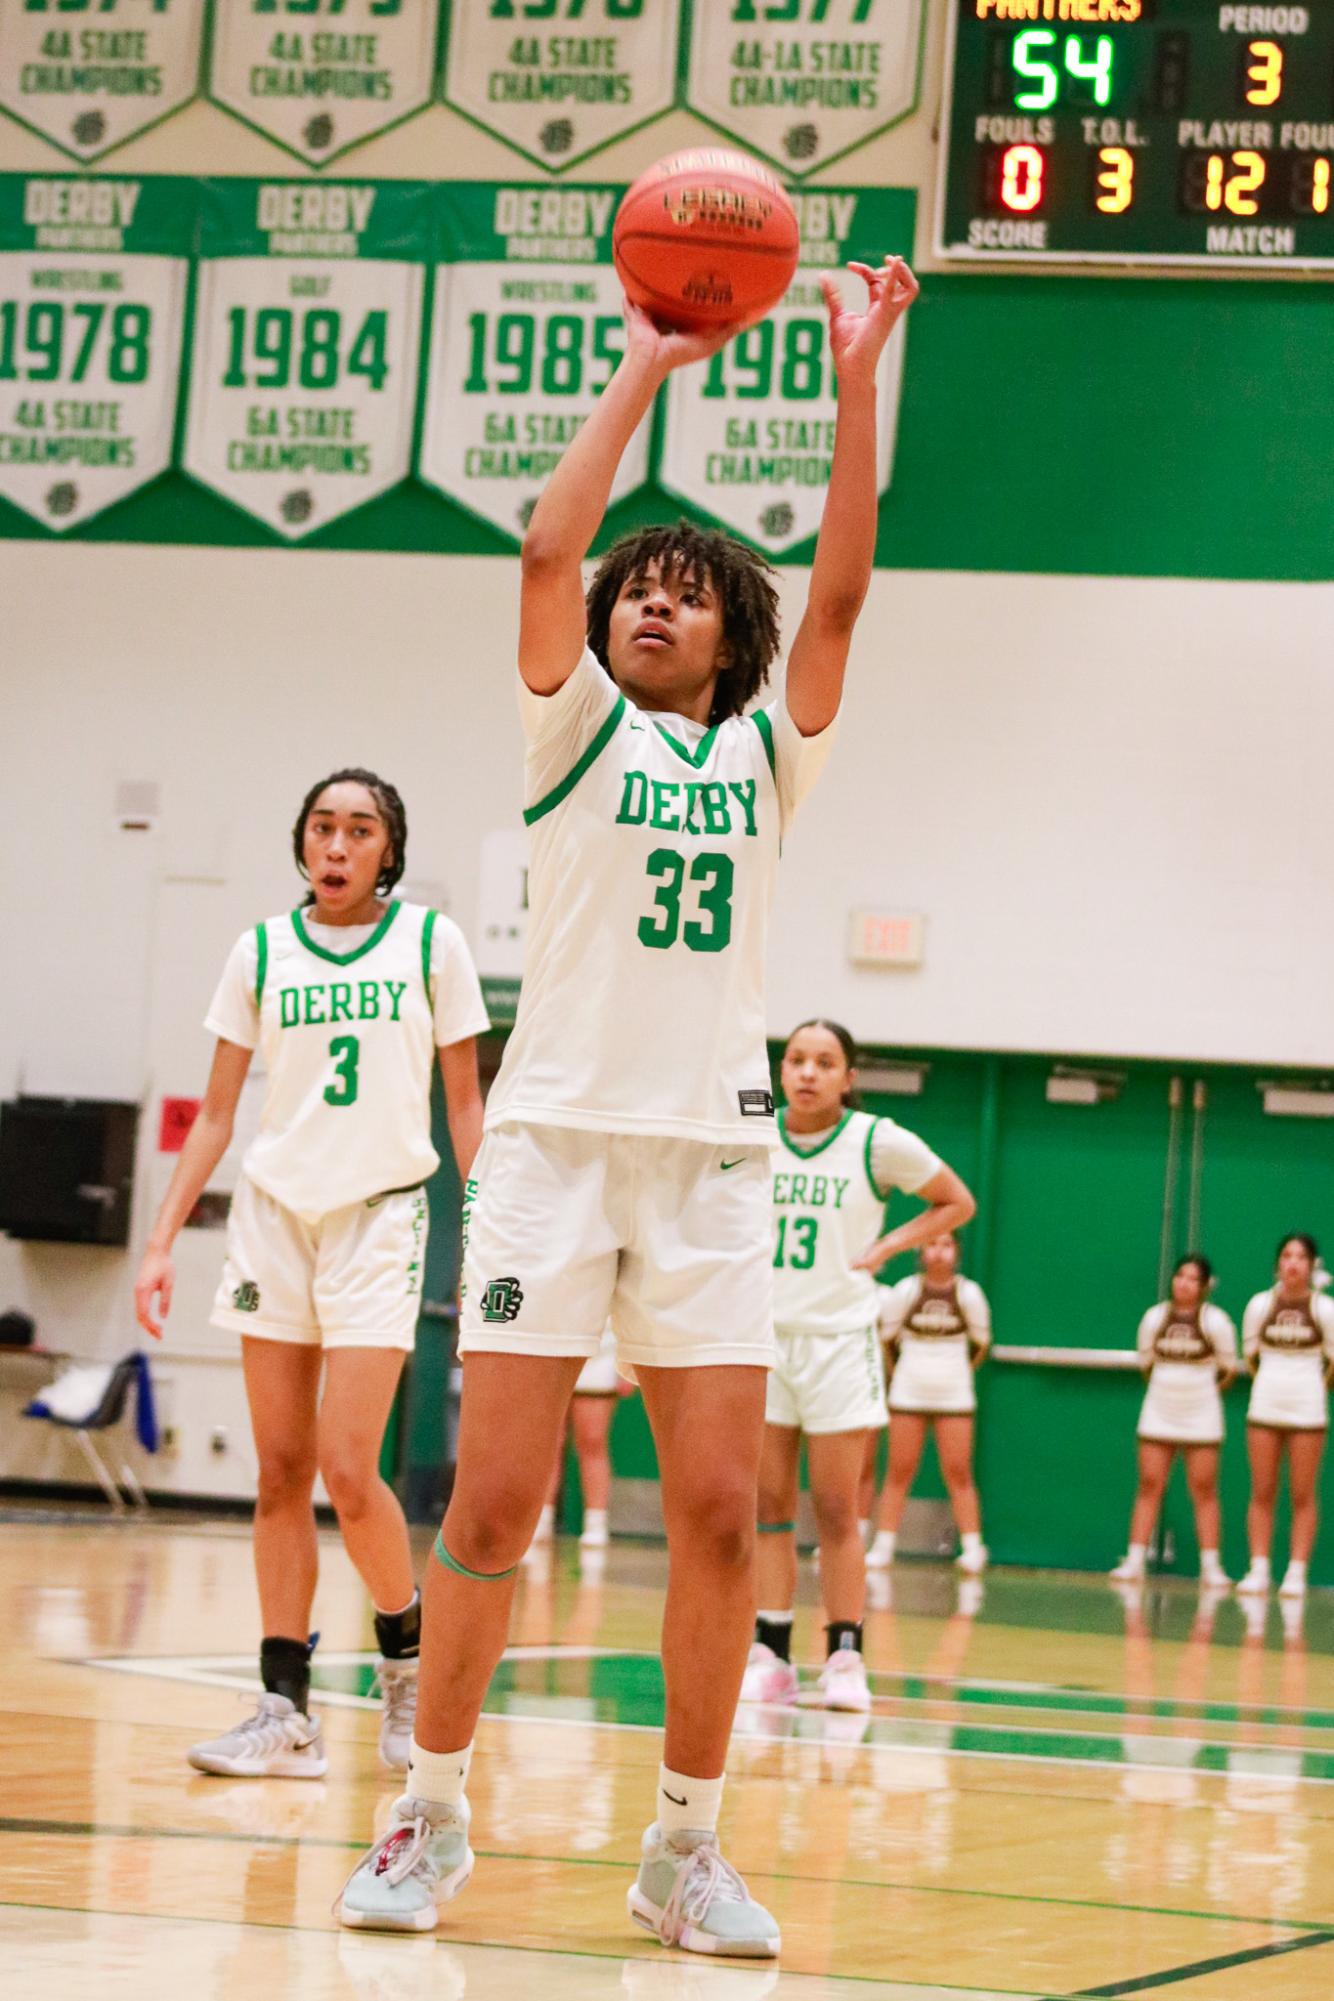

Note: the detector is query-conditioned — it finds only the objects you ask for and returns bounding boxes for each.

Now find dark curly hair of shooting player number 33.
[584,520,778,724]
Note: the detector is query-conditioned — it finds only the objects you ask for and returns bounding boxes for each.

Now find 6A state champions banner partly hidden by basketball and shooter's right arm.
[658,188,916,556]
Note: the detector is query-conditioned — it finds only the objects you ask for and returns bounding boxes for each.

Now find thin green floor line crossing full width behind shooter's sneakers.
[0,1815,1334,1936]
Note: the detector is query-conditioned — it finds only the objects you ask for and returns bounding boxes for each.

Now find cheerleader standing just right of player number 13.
[866,1231,992,1577]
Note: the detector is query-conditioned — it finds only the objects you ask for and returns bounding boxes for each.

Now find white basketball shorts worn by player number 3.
[210,1175,426,1349]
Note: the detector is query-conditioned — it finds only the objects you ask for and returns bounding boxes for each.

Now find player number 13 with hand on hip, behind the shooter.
[742,1021,974,1711]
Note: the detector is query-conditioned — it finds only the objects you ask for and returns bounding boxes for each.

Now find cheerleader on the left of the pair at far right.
[1112,1251,1238,1591]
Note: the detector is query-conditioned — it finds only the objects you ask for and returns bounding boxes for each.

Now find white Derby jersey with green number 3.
[244,902,440,1221]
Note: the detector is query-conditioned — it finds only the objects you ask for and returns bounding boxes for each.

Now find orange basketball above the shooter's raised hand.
[612,146,800,326]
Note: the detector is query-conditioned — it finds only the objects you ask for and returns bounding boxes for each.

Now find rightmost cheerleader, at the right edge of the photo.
[1236,1231,1334,1599]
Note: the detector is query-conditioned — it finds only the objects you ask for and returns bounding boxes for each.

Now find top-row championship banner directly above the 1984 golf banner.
[208,0,438,166]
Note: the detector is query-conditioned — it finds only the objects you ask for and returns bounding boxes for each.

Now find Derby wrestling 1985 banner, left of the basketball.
[418,182,650,538]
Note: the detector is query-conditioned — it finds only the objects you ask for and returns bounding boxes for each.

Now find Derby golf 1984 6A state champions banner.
[184,180,430,540]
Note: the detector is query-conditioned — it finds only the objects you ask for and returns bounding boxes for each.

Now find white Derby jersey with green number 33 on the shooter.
[486,650,832,1147]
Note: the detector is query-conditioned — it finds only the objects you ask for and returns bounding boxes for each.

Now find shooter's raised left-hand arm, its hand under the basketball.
[518,300,742,694]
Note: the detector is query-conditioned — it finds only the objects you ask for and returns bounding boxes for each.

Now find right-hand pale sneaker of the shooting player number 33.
[626,1821,782,1959]
